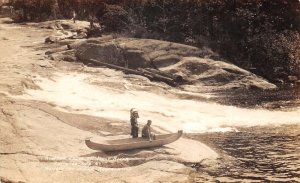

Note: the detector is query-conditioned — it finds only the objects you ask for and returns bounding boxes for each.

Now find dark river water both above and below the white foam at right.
[188,88,300,182]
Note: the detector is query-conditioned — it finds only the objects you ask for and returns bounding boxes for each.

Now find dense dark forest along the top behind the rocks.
[4,0,300,84]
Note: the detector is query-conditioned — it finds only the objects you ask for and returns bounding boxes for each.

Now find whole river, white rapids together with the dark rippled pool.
[15,73,300,182]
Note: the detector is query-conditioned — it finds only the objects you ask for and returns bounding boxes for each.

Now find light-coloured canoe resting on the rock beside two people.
[85,130,182,151]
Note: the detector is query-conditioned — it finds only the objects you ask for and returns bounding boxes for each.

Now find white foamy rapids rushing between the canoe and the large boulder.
[18,73,300,133]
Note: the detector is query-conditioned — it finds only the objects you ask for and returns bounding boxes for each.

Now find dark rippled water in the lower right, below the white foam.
[190,125,300,182]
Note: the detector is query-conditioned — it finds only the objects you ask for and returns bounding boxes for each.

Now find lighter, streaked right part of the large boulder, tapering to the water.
[162,57,276,90]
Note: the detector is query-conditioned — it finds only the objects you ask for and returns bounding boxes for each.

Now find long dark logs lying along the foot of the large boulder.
[89,59,178,86]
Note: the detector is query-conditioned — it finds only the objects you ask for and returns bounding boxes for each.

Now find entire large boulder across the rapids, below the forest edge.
[52,36,276,92]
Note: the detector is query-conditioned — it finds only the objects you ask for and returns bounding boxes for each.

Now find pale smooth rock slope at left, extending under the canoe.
[0,19,218,182]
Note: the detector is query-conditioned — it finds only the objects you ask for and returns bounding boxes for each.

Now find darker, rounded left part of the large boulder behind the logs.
[71,37,216,69]
